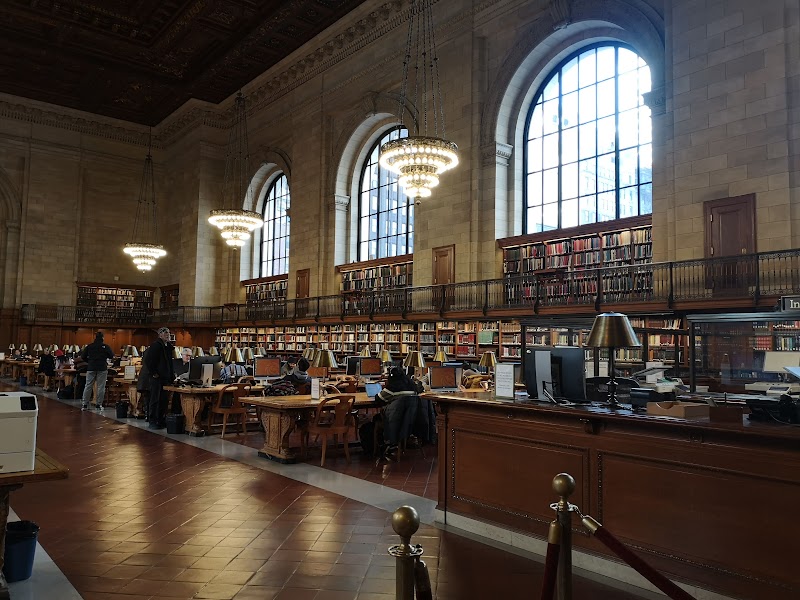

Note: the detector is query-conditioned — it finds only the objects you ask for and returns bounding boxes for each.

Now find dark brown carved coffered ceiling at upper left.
[0,0,365,125]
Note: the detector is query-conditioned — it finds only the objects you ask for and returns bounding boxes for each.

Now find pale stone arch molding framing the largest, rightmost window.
[481,0,665,238]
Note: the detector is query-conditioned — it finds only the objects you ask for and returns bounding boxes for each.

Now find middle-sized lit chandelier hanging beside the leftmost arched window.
[208,91,264,248]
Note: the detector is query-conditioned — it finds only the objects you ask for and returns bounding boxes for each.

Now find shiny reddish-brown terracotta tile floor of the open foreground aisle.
[6,384,648,600]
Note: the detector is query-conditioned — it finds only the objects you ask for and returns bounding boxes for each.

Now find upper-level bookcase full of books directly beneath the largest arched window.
[498,216,653,305]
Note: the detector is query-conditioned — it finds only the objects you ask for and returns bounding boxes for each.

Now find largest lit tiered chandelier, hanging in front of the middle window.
[380,0,458,204]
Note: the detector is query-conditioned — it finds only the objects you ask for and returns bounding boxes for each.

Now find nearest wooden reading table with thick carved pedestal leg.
[240,392,378,463]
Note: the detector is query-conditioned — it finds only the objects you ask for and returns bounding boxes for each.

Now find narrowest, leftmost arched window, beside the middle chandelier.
[261,174,291,277]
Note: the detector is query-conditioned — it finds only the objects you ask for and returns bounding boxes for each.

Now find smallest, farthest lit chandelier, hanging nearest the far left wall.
[123,130,167,272]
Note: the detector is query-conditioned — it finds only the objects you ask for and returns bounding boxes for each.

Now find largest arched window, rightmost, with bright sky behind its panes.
[523,43,653,233]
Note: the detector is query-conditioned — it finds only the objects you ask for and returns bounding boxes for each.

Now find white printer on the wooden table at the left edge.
[0,392,39,473]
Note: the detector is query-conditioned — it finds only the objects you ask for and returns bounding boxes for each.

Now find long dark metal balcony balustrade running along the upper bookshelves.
[20,249,800,327]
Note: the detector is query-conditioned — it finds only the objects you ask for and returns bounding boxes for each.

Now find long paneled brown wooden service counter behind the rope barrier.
[425,392,800,600]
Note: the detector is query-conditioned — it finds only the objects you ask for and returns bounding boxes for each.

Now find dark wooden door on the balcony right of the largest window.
[703,194,757,295]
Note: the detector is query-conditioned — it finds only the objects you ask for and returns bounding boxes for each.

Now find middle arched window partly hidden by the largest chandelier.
[358,127,414,260]
